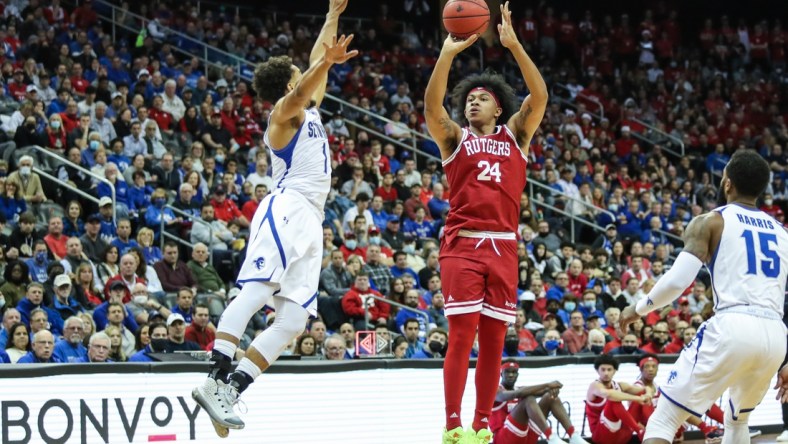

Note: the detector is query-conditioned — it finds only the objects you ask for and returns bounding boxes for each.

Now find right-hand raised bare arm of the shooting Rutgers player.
[498,1,548,152]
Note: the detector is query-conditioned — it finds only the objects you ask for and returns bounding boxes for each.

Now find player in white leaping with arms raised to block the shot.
[192,0,358,436]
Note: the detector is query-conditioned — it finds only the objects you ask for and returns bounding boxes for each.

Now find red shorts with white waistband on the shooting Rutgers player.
[440,236,518,323]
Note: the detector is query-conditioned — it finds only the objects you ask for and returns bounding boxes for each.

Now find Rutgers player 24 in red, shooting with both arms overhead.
[424,2,547,444]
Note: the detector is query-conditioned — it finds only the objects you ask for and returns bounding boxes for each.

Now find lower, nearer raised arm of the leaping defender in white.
[271,34,358,125]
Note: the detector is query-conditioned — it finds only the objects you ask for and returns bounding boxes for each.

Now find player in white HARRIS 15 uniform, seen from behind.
[620,150,788,444]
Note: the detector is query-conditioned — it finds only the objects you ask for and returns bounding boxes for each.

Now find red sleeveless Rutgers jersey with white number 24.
[443,125,528,241]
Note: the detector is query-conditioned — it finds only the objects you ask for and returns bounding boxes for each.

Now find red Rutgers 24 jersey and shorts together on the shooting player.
[440,125,528,322]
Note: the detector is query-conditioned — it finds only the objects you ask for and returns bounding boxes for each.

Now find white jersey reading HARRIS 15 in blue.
[708,204,788,316]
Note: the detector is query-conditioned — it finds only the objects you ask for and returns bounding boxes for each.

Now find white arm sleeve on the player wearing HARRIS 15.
[635,251,703,316]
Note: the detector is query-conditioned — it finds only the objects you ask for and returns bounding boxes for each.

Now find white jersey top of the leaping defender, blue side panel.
[263,107,331,213]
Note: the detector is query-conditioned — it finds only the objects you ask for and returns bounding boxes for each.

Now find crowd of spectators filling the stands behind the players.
[0,0,788,363]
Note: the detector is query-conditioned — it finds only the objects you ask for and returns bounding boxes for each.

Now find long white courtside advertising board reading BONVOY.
[0,364,782,444]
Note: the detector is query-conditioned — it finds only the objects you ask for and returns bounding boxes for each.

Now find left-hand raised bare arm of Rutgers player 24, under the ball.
[424,34,479,159]
